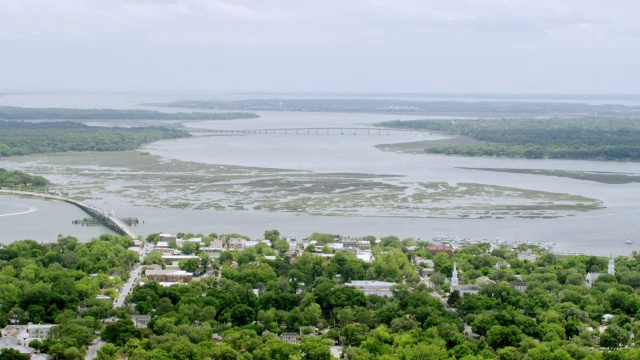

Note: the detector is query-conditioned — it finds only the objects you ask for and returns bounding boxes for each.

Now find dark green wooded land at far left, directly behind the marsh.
[0,121,189,157]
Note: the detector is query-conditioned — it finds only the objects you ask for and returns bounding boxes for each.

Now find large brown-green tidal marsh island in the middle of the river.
[3,151,603,219]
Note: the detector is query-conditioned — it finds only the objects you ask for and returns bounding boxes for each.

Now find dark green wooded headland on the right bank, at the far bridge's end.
[377,118,640,161]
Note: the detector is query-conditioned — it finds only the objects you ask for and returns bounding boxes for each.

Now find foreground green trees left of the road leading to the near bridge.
[0,235,138,360]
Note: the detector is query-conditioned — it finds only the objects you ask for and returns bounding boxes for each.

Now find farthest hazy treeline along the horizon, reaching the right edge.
[149,99,640,116]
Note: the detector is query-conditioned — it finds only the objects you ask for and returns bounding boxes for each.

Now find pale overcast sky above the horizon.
[0,0,640,94]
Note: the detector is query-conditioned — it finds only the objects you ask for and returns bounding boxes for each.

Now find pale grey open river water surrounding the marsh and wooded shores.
[0,95,640,255]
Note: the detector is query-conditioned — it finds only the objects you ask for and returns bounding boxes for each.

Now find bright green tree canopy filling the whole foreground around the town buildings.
[0,231,640,360]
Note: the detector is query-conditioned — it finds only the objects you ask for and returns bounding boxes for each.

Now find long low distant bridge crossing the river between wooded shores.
[186,127,454,136]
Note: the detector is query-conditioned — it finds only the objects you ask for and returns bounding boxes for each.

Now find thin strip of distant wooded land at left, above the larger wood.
[0,106,258,121]
